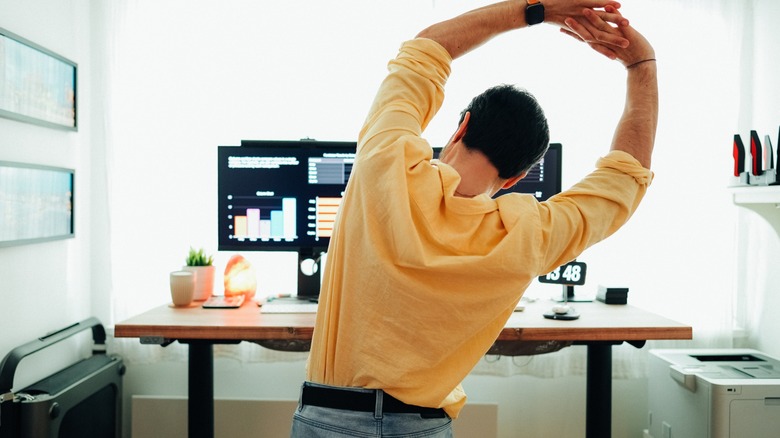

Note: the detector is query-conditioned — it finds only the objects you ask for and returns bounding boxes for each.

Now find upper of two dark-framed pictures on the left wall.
[0,28,78,131]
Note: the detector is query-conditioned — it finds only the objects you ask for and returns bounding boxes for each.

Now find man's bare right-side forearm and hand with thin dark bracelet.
[564,8,658,169]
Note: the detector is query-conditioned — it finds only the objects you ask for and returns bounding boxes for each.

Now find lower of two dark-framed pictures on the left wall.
[0,161,74,247]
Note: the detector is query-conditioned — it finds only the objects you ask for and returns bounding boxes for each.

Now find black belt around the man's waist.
[301,385,447,418]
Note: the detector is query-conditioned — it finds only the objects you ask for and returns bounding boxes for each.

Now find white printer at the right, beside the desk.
[644,349,780,438]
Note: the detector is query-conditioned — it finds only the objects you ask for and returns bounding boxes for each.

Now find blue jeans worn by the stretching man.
[290,382,453,438]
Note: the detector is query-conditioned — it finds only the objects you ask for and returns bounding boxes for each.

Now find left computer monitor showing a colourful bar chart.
[217,140,356,298]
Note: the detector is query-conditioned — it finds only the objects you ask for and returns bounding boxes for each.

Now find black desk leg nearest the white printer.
[585,342,612,438]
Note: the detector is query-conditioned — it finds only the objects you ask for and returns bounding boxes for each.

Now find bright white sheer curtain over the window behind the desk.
[96,0,746,376]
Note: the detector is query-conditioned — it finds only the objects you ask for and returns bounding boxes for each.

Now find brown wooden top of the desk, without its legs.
[114,300,693,341]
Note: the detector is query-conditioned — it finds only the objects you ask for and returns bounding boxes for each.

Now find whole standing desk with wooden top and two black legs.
[114,301,693,438]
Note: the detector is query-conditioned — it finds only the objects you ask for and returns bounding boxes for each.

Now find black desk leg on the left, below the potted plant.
[187,341,214,438]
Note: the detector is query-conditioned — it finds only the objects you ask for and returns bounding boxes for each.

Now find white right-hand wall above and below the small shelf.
[734,0,780,356]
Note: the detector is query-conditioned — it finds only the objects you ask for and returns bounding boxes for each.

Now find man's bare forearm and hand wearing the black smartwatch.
[417,0,628,59]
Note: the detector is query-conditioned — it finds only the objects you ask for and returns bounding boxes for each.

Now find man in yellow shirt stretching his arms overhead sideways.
[292,0,657,438]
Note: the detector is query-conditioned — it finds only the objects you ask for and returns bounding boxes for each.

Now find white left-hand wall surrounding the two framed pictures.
[0,0,93,389]
